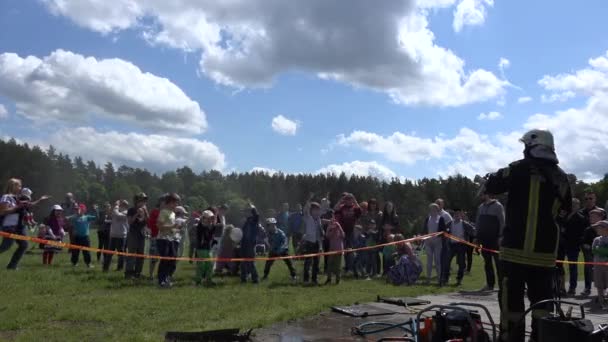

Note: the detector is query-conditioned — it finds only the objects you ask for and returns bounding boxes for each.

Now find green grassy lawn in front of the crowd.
[0,232,484,341]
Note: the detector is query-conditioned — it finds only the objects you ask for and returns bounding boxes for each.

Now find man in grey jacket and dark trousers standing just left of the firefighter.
[475,193,505,291]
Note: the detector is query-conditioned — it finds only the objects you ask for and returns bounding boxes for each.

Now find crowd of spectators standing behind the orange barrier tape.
[0,179,608,295]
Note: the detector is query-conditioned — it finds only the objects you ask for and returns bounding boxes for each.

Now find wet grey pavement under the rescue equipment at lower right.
[253,284,608,342]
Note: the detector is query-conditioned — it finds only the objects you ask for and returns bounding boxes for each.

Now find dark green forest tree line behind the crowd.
[0,139,608,235]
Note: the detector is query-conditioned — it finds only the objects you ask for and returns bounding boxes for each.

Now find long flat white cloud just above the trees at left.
[49,127,226,172]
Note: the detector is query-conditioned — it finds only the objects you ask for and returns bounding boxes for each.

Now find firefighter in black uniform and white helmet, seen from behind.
[485,130,572,342]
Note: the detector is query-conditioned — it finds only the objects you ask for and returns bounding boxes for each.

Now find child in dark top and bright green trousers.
[194,210,221,286]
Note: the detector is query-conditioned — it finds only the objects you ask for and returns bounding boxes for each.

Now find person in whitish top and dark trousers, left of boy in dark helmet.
[103,200,129,272]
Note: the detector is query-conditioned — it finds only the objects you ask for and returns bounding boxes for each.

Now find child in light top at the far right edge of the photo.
[591,221,608,310]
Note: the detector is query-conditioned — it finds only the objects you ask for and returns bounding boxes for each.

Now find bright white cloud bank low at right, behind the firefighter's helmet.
[338,51,608,181]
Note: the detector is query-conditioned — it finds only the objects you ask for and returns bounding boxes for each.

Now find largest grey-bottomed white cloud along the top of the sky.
[44,0,508,106]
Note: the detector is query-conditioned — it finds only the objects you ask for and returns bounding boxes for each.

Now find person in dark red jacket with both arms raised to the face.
[335,193,361,273]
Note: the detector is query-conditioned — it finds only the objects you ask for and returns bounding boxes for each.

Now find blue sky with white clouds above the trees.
[0,0,608,181]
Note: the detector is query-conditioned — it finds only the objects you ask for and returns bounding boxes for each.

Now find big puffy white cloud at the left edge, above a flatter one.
[0,50,207,133]
